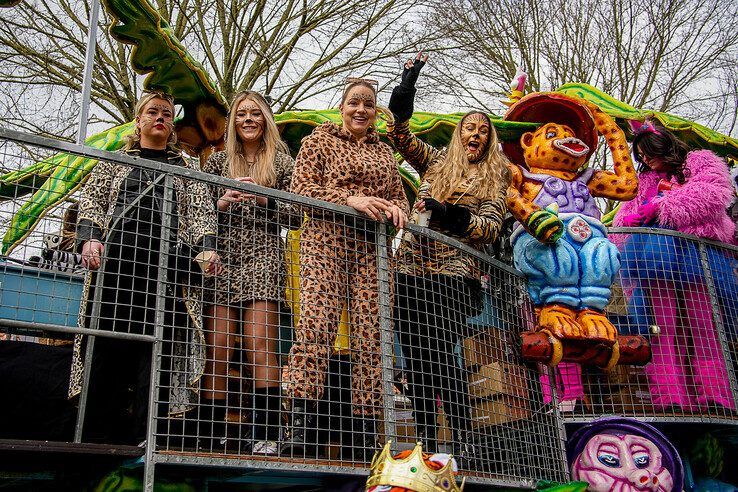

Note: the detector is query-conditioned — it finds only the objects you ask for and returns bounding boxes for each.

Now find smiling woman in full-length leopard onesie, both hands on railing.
[286,79,408,461]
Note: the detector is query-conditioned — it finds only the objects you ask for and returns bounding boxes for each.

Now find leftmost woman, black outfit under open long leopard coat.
[70,92,221,442]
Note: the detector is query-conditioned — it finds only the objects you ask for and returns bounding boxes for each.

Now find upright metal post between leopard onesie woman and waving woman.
[376,223,397,451]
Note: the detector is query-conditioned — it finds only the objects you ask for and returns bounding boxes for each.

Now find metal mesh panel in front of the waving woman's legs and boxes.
[392,226,564,481]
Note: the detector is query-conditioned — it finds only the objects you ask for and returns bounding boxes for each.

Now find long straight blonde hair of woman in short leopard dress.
[226,91,289,187]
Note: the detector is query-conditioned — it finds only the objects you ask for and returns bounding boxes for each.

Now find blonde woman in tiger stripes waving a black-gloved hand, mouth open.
[387,54,510,466]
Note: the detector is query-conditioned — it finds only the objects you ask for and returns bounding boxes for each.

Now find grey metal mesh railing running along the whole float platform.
[0,130,738,488]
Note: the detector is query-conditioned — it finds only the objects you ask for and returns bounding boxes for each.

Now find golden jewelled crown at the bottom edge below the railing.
[366,441,464,492]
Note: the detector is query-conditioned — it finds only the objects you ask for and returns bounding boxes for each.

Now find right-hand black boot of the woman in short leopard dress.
[251,386,282,455]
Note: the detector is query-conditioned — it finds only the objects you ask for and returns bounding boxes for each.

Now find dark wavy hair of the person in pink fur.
[632,126,690,184]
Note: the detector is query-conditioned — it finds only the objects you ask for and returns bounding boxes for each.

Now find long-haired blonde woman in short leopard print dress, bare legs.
[199,91,301,454]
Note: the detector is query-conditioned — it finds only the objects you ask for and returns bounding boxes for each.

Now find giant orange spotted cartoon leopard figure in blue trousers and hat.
[504,93,638,364]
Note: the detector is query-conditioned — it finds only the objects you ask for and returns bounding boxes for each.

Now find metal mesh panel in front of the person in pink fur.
[555,228,738,421]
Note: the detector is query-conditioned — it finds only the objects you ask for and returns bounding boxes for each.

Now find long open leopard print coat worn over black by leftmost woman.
[69,148,217,413]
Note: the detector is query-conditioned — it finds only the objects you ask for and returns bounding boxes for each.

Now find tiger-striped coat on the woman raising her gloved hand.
[387,121,506,278]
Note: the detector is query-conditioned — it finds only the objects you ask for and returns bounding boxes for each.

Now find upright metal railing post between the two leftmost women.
[144,174,174,492]
